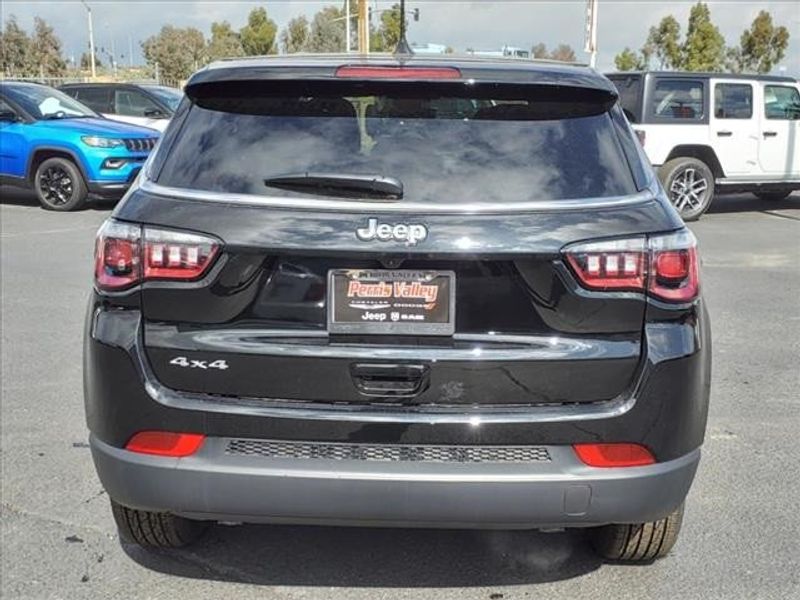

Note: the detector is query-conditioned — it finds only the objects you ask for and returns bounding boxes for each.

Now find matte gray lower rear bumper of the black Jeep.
[90,437,700,529]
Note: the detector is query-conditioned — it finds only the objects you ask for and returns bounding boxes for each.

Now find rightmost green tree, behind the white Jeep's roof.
[728,10,789,73]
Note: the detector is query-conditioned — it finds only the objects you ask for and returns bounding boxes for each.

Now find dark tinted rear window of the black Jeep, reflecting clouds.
[157,83,636,204]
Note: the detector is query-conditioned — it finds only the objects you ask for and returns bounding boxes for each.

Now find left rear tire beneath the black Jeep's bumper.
[111,500,208,548]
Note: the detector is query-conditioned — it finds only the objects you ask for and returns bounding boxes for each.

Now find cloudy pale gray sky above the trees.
[0,0,800,77]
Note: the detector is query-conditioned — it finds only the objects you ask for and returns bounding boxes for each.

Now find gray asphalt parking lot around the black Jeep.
[0,188,800,600]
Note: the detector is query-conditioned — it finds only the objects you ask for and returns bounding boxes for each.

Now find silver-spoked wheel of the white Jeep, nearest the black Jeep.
[658,156,714,221]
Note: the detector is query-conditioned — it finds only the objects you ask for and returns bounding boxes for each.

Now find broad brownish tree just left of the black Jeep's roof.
[142,25,206,81]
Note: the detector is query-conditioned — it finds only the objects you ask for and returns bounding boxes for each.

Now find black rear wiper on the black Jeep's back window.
[264,173,403,200]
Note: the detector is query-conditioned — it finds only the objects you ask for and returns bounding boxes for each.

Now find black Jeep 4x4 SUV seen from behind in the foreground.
[85,55,711,561]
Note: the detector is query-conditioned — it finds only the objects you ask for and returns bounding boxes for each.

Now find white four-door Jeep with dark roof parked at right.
[607,71,800,221]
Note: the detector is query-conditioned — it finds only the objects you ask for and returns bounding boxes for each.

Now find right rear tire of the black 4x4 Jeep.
[591,504,683,563]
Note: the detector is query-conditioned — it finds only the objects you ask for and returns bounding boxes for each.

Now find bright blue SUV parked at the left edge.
[0,82,159,211]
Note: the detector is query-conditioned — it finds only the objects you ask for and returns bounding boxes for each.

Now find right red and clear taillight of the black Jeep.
[564,230,700,302]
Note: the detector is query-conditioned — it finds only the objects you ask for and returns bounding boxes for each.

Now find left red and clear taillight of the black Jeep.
[94,219,220,291]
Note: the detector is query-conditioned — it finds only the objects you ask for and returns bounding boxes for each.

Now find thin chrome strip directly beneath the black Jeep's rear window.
[139,176,653,215]
